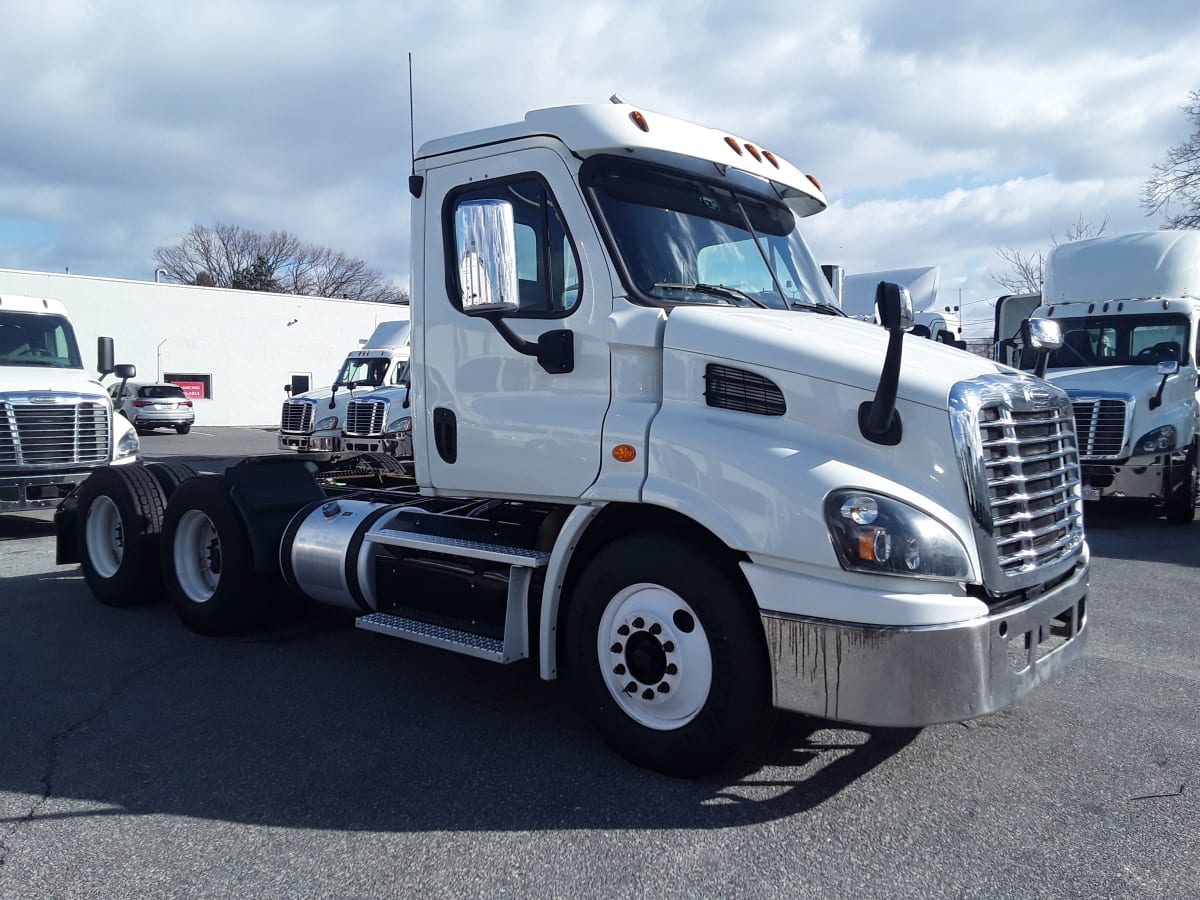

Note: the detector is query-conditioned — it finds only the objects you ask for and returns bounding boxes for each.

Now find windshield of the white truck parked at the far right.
[1021,314,1190,370]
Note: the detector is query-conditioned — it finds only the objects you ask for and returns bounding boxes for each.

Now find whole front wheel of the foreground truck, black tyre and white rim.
[569,534,769,778]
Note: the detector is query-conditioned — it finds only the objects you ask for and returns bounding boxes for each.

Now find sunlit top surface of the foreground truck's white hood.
[664,306,1012,409]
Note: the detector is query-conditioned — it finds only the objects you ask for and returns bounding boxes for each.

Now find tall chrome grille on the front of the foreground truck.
[950,378,1084,590]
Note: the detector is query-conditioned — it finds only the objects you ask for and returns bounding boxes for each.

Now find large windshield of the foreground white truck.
[583,157,838,311]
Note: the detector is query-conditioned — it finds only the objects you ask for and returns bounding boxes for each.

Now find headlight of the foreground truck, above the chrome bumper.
[824,490,971,581]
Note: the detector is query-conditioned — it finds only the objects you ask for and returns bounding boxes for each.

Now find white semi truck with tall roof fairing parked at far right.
[996,232,1200,523]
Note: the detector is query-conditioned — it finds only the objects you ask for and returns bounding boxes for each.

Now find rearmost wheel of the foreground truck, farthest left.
[76,466,166,606]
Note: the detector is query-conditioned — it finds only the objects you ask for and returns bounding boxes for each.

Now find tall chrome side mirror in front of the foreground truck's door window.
[454,199,521,316]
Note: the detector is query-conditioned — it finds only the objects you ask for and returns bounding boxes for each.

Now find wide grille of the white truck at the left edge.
[0,401,112,469]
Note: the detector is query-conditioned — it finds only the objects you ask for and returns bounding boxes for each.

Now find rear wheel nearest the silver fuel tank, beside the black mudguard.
[161,475,264,635]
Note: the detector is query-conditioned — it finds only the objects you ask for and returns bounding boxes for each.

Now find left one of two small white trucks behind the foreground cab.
[278,319,409,454]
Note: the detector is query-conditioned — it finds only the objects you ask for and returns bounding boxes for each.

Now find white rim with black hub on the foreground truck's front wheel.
[596,583,713,731]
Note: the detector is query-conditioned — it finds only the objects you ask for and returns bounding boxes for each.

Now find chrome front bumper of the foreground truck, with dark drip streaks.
[762,565,1088,727]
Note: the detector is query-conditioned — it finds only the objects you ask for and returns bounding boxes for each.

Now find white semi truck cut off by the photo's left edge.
[0,294,138,512]
